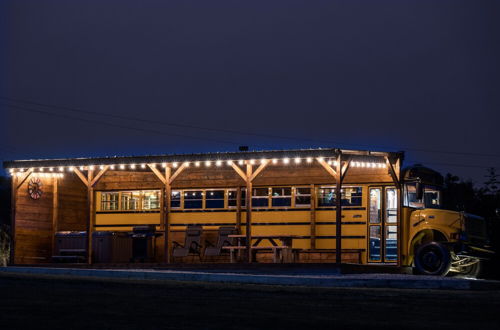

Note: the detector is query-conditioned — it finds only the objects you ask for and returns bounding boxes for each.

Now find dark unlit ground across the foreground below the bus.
[0,275,500,329]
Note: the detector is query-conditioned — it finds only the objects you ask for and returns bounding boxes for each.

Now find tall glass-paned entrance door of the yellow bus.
[368,186,398,263]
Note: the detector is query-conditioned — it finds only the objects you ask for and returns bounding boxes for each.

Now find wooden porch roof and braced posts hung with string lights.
[4,148,403,264]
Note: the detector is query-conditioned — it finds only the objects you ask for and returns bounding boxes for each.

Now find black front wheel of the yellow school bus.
[415,242,451,276]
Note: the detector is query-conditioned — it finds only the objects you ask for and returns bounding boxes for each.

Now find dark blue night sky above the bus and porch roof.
[0,0,500,183]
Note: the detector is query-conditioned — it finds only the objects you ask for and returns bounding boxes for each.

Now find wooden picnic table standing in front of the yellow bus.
[223,235,300,263]
